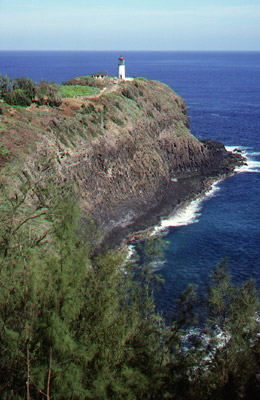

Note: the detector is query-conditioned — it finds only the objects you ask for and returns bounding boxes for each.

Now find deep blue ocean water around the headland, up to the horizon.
[0,51,260,314]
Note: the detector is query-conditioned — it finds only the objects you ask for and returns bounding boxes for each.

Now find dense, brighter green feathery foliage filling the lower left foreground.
[0,179,166,399]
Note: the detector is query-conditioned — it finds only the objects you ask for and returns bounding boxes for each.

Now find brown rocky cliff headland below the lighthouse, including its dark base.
[1,78,244,245]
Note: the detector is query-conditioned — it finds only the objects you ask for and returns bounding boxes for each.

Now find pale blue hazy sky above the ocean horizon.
[0,0,260,50]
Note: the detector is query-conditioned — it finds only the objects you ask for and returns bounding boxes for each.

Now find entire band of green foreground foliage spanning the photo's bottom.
[0,171,260,400]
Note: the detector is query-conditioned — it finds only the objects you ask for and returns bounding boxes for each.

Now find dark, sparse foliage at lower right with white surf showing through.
[165,260,260,400]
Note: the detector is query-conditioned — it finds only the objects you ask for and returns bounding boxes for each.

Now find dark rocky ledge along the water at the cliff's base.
[97,140,246,251]
